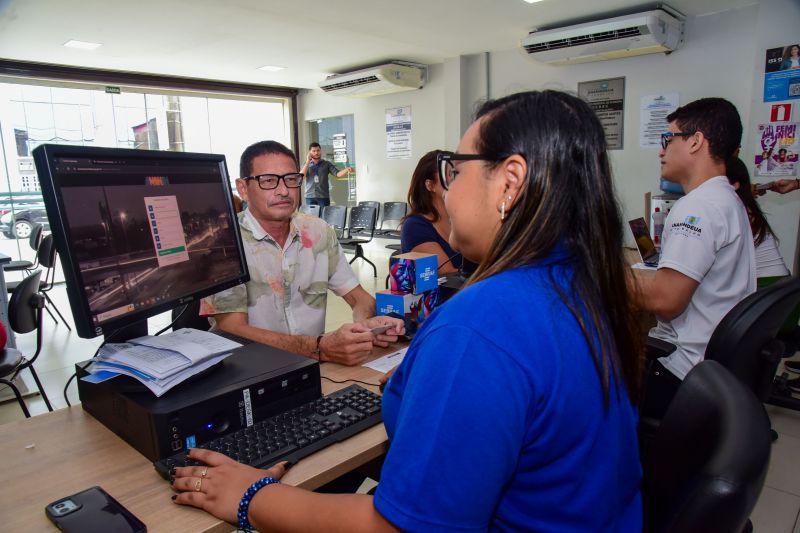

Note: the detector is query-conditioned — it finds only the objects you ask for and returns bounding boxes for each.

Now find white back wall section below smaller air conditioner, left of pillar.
[298,61,445,202]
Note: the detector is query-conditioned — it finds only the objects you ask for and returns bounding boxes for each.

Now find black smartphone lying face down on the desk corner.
[44,487,147,533]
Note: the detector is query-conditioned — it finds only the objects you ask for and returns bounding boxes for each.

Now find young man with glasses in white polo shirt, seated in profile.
[636,98,756,418]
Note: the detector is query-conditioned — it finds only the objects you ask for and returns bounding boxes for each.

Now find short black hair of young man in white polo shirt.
[667,98,742,161]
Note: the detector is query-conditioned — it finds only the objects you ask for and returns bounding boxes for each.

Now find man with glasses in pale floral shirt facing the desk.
[200,141,403,365]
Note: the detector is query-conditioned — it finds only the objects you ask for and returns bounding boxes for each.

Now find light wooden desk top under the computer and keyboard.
[0,345,398,533]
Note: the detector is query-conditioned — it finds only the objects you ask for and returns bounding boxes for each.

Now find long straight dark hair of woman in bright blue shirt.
[470,91,644,403]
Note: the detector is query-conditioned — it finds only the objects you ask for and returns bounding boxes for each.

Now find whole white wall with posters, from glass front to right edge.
[300,0,800,268]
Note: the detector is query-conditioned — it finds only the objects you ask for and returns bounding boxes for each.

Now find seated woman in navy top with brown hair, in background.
[400,150,462,274]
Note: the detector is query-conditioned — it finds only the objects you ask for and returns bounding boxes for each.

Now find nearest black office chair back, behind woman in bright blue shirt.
[642,361,771,533]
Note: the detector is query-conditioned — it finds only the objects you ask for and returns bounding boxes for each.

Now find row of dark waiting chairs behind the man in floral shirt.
[301,201,408,277]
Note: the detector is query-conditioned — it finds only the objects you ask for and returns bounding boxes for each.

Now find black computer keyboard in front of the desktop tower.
[153,385,383,480]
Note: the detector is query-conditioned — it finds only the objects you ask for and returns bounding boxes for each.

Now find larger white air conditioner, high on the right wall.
[520,8,683,65]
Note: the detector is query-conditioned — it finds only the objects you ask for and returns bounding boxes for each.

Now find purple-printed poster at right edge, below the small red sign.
[755,122,800,177]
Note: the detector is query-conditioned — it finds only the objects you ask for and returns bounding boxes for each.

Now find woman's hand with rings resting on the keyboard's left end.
[172,448,287,524]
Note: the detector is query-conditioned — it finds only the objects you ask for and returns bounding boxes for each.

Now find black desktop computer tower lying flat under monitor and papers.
[75,339,322,461]
